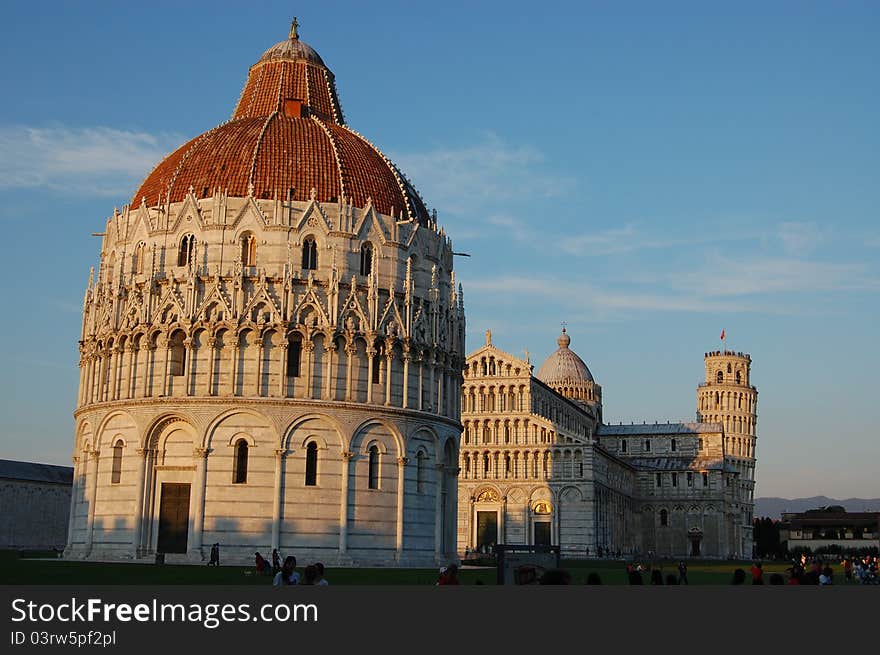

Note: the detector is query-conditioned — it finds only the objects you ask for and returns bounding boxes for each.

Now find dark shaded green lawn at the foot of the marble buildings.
[0,551,843,585]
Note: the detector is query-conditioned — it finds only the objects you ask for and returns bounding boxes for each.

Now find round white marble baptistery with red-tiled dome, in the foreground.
[65,21,465,566]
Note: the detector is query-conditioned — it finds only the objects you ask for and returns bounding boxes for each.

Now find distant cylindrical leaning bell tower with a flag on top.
[697,350,758,557]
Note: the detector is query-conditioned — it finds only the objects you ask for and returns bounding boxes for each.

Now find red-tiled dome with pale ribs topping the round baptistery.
[131,23,429,225]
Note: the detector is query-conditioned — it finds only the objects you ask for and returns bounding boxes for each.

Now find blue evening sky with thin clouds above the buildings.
[0,0,880,498]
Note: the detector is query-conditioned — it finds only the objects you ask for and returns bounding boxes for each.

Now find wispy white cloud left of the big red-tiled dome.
[0,125,183,198]
